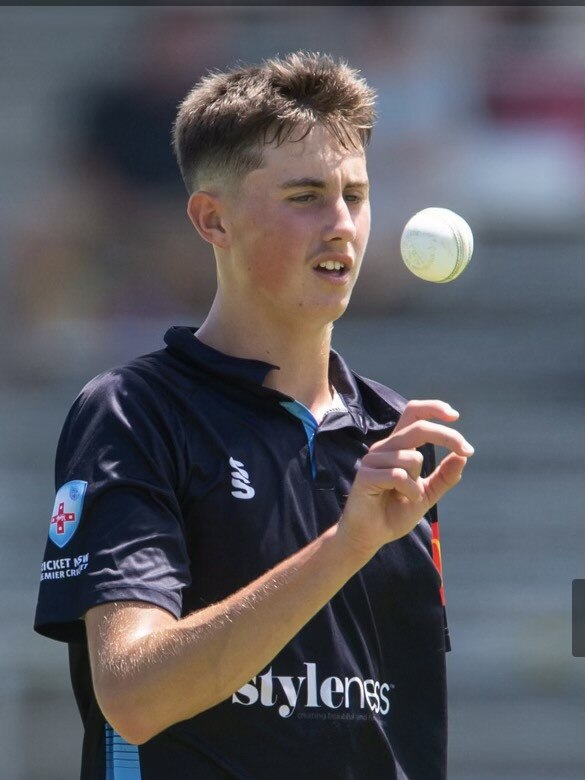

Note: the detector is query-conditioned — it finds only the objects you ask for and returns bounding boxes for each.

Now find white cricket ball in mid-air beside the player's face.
[400,208,473,282]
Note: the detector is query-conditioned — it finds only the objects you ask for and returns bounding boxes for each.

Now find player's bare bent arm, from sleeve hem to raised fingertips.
[86,401,472,743]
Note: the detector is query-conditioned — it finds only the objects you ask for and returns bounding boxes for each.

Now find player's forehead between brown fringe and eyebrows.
[249,125,367,185]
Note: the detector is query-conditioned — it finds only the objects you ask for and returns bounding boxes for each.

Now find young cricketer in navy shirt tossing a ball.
[36,53,473,780]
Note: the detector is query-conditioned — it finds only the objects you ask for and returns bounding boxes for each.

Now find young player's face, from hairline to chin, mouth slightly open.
[220,126,370,326]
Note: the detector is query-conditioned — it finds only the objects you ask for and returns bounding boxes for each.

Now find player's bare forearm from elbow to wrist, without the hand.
[96,525,373,742]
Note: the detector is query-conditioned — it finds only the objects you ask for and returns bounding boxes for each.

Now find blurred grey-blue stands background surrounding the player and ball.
[0,6,585,780]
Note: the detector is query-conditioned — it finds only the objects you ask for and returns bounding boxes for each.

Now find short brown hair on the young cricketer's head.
[173,52,376,192]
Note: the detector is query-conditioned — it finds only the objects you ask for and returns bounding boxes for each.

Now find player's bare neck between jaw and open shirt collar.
[197,298,333,418]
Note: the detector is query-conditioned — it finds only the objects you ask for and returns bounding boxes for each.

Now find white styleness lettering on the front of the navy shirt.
[232,662,394,718]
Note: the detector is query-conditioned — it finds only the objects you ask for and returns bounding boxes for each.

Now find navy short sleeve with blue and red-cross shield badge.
[34,368,190,641]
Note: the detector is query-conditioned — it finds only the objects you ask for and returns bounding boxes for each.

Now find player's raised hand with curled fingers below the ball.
[339,400,474,558]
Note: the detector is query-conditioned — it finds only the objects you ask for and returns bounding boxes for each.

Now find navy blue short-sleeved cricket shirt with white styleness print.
[35,327,448,780]
